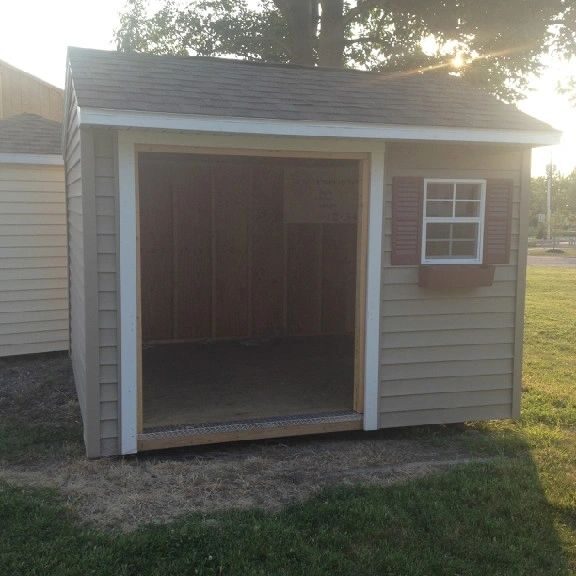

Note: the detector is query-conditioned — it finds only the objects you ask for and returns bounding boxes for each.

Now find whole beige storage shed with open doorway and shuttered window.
[65,48,559,457]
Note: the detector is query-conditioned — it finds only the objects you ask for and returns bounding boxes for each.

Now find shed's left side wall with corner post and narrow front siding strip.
[65,80,120,457]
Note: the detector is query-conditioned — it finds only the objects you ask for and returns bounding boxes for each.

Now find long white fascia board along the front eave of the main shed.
[78,108,560,146]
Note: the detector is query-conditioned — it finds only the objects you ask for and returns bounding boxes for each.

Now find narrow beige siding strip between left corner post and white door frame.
[94,130,120,456]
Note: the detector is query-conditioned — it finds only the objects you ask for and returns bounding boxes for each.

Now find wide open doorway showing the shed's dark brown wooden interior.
[138,152,363,433]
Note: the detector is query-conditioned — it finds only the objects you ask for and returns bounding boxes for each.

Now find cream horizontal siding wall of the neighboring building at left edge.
[0,164,68,356]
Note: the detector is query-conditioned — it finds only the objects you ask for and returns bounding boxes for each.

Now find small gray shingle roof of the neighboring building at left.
[0,114,62,154]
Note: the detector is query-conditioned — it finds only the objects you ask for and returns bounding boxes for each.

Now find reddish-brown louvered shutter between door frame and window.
[392,176,424,264]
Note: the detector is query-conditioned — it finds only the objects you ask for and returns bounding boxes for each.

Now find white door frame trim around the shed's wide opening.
[118,130,385,454]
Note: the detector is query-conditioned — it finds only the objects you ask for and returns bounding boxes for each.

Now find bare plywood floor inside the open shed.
[143,336,354,430]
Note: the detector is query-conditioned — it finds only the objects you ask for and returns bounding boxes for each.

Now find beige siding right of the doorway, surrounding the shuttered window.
[379,143,523,427]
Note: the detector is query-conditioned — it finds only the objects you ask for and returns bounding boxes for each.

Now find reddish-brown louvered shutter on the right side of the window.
[484,180,514,264]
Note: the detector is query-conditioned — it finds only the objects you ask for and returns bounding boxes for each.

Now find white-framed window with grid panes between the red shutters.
[422,179,486,264]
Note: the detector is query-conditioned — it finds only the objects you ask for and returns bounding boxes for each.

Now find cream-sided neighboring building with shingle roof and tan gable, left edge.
[0,67,69,356]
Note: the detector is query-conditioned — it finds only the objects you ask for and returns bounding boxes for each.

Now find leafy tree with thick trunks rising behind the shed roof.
[115,0,576,100]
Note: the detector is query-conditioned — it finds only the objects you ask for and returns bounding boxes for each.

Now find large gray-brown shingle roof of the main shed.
[68,48,552,131]
